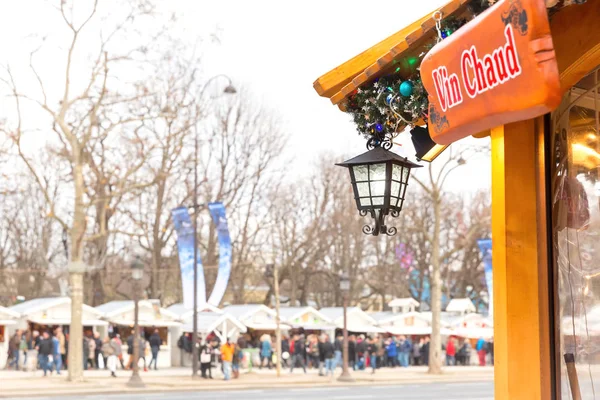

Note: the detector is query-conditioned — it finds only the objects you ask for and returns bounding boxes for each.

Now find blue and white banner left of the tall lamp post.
[171,207,206,309]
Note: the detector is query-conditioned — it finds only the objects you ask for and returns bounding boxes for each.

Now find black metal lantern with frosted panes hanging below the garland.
[337,140,420,236]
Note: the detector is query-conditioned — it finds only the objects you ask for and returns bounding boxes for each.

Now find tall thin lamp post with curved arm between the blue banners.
[192,74,237,378]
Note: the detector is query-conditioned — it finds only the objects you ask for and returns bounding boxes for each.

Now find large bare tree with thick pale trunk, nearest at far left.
[4,0,164,381]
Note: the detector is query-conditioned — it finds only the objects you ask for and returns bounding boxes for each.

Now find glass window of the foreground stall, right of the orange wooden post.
[552,66,600,400]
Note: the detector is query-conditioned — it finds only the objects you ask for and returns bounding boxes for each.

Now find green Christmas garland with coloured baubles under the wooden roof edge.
[346,0,586,139]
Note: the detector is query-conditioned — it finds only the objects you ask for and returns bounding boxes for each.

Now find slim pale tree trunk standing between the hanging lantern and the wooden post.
[429,191,442,374]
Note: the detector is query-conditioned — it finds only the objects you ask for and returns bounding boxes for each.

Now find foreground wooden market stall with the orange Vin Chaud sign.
[314,0,600,400]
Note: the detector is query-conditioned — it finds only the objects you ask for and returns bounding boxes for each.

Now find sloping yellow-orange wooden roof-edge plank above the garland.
[313,0,461,97]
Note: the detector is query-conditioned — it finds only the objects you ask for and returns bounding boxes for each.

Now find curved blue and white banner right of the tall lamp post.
[208,203,231,306]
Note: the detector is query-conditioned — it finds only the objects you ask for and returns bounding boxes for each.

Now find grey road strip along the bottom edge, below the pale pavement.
[4,382,494,400]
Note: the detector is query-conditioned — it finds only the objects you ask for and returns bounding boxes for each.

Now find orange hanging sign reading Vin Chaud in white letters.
[421,0,561,144]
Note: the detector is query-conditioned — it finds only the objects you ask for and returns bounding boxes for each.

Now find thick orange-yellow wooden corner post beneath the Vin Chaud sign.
[491,118,554,400]
